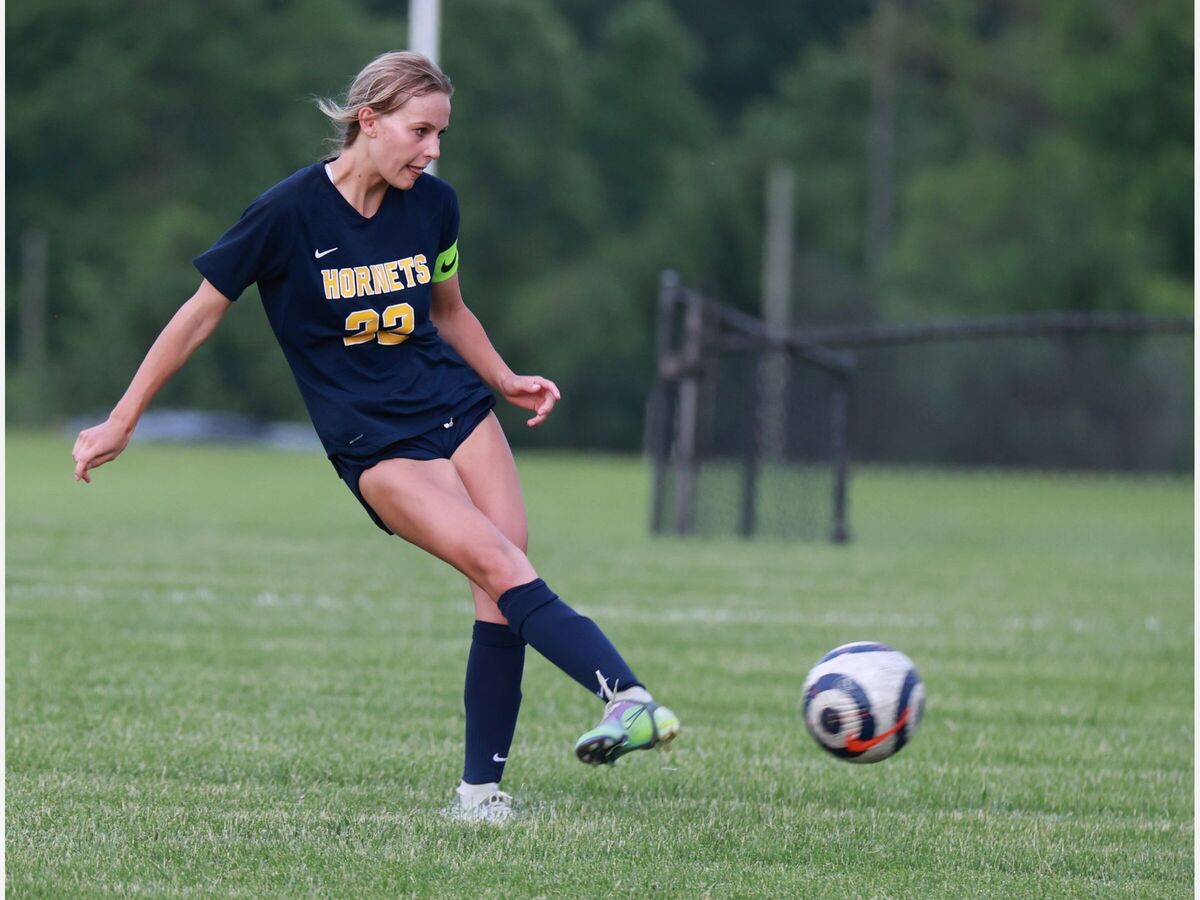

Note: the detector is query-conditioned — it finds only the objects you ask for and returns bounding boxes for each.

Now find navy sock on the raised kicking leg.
[497,578,641,696]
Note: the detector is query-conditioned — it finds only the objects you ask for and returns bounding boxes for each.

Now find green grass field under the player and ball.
[6,433,1194,898]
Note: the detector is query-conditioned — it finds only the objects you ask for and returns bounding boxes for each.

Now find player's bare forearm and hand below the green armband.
[430,275,562,426]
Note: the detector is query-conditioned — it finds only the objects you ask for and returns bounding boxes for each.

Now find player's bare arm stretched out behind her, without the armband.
[71,278,232,484]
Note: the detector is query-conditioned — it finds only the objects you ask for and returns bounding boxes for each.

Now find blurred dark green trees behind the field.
[5,0,1194,450]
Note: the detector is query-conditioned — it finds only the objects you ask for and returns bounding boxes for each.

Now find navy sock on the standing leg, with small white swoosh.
[462,622,526,785]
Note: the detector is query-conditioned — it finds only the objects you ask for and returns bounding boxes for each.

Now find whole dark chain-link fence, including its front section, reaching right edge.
[646,274,1194,541]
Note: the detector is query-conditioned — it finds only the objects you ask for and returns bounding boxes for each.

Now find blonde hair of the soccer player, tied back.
[317,50,454,150]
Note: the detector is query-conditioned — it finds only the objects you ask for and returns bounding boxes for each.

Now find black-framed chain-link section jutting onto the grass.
[647,274,851,541]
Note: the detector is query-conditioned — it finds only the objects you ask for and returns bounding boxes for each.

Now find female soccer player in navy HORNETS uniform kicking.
[73,52,679,821]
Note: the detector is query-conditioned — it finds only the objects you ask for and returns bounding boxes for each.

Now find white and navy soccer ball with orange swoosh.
[804,641,925,762]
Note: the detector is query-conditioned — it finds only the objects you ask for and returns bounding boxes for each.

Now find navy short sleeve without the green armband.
[192,193,288,300]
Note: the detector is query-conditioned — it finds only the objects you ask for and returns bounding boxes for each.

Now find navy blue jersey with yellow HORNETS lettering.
[194,162,488,457]
